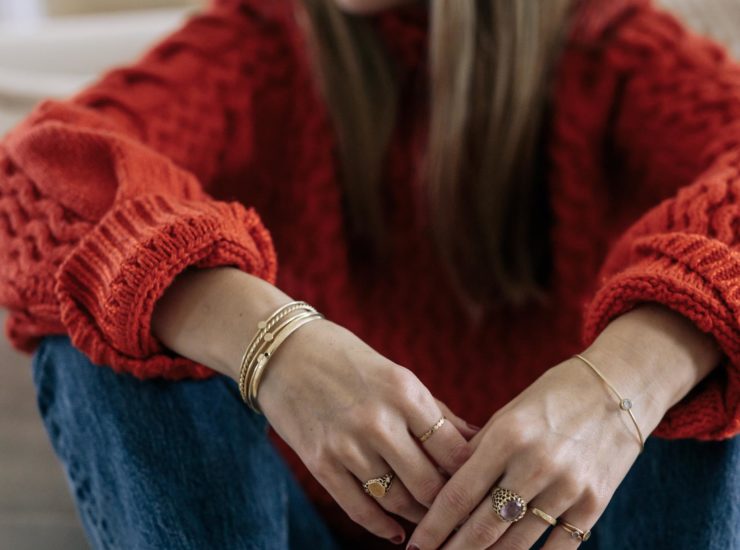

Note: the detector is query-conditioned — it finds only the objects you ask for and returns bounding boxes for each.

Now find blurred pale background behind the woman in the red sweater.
[0,0,740,550]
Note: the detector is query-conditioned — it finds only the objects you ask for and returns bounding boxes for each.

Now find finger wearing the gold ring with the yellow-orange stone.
[344,451,430,523]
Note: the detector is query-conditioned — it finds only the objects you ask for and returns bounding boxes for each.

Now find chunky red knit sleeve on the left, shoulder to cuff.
[0,0,286,379]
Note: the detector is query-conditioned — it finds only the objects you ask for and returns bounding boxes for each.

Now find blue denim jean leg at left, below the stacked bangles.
[33,335,334,549]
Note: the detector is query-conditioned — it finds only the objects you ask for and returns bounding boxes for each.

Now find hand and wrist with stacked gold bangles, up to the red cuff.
[152,267,476,542]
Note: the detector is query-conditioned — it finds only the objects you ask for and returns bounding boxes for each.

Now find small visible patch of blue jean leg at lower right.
[536,437,740,550]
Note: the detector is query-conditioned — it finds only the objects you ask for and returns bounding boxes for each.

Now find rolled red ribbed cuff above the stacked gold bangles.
[55,194,277,379]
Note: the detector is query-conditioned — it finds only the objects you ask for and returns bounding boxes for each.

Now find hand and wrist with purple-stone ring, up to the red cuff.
[408,306,719,550]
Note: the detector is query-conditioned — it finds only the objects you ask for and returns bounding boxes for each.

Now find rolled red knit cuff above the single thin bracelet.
[583,233,740,440]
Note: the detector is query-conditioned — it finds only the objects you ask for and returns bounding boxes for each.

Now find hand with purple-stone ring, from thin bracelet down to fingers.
[404,359,640,550]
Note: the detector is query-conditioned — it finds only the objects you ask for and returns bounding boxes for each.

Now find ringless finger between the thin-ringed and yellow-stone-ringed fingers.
[378,430,447,508]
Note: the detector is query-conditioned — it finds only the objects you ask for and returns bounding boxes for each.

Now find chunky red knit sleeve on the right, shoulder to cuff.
[584,3,740,439]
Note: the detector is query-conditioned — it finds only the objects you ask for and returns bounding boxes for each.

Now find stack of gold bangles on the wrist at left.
[239,301,324,413]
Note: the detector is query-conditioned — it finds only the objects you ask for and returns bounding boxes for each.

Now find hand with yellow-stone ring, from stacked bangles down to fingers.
[258,319,477,544]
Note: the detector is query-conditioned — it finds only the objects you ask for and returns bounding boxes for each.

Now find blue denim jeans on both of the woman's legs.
[33,336,740,550]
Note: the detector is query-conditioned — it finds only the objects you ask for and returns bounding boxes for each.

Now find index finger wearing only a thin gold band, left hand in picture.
[407,394,473,475]
